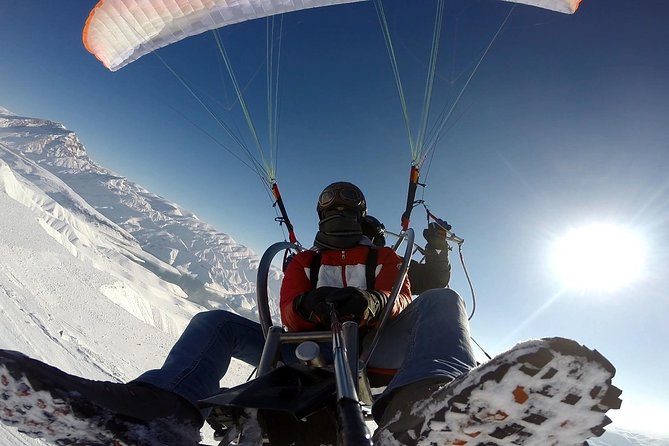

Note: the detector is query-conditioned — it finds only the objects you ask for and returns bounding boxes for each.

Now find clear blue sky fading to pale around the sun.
[0,0,669,438]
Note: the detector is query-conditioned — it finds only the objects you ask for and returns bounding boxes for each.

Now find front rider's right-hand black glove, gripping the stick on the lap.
[325,287,388,325]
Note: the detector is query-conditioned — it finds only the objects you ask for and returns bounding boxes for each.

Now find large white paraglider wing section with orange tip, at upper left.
[83,0,363,71]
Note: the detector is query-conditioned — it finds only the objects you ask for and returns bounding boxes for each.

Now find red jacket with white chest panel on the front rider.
[280,245,411,331]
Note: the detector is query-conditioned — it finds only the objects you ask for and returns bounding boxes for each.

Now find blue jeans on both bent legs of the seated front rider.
[135,288,476,414]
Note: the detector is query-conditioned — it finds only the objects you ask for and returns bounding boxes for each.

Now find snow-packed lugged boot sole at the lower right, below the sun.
[374,338,621,446]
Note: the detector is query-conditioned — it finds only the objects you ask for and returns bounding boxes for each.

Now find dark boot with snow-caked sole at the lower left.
[0,350,202,446]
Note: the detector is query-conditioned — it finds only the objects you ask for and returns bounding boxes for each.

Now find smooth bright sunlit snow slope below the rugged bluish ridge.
[0,160,249,446]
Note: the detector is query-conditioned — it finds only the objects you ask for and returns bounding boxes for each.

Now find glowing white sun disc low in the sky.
[552,223,644,292]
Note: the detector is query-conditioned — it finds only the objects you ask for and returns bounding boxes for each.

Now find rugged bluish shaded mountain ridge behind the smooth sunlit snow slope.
[0,110,279,318]
